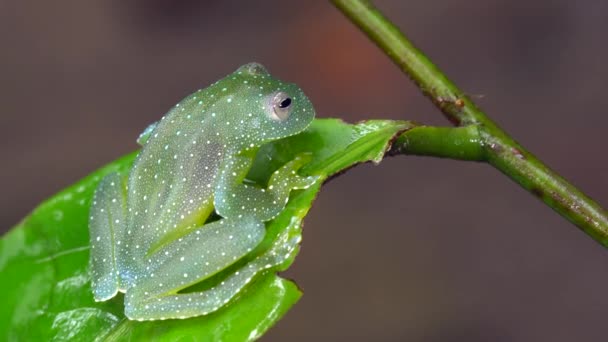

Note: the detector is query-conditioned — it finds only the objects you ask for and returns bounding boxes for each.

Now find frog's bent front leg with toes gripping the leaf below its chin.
[214,154,319,221]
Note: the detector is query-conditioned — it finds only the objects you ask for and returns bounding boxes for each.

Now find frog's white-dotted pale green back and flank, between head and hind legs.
[127,89,225,253]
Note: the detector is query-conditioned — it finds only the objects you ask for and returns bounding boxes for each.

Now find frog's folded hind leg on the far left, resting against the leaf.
[89,173,126,301]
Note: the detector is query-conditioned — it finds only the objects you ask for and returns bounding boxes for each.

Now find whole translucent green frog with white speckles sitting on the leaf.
[89,63,317,320]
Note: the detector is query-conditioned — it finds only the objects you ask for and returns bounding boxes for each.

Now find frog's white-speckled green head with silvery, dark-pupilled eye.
[228,63,315,143]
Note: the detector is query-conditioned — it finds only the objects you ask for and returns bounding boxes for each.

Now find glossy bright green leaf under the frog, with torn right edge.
[0,119,411,341]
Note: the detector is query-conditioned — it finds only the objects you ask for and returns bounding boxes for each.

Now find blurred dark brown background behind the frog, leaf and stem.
[0,0,608,341]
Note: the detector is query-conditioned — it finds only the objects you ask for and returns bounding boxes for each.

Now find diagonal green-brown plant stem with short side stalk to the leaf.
[332,0,608,246]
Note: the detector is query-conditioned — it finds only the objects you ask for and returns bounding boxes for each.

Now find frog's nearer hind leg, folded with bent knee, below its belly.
[125,218,265,320]
